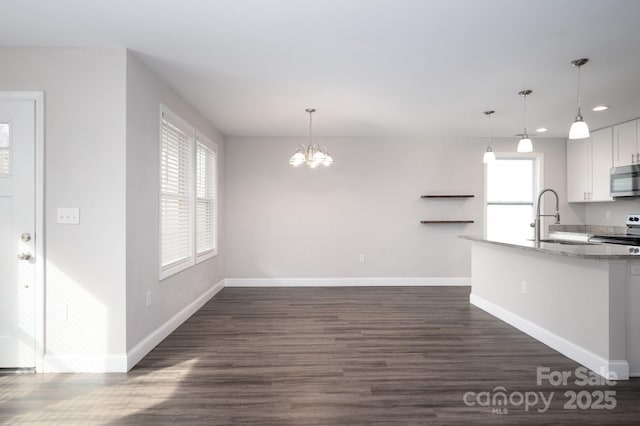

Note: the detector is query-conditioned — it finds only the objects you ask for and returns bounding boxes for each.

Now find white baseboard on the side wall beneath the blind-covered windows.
[124,280,225,371]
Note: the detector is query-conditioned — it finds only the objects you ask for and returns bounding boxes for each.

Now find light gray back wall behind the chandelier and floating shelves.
[225,137,582,278]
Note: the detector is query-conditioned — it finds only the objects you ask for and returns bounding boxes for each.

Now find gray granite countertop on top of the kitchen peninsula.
[459,235,640,260]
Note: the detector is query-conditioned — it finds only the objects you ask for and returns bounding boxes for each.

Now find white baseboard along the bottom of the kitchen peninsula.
[469,293,629,380]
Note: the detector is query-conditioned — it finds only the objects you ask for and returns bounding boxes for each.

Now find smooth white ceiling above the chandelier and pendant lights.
[0,0,640,137]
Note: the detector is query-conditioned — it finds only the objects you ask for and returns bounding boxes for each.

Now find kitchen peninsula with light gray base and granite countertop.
[461,236,640,380]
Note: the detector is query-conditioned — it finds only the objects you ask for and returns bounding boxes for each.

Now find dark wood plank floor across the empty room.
[0,287,640,425]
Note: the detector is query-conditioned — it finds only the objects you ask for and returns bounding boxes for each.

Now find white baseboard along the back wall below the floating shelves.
[224,277,471,287]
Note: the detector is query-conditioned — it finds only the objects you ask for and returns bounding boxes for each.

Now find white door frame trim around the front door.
[0,92,46,373]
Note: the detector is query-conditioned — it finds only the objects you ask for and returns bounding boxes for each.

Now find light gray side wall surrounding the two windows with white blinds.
[126,52,224,351]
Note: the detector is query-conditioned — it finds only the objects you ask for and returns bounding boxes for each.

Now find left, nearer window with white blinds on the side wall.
[160,108,195,279]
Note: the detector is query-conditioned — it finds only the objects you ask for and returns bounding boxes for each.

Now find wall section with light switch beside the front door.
[0,47,126,370]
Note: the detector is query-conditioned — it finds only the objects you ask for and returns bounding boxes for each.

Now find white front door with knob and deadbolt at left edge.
[0,100,39,368]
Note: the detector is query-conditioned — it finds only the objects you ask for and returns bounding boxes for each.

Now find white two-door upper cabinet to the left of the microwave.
[567,127,613,203]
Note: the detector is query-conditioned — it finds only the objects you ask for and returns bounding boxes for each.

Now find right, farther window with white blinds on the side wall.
[196,134,218,262]
